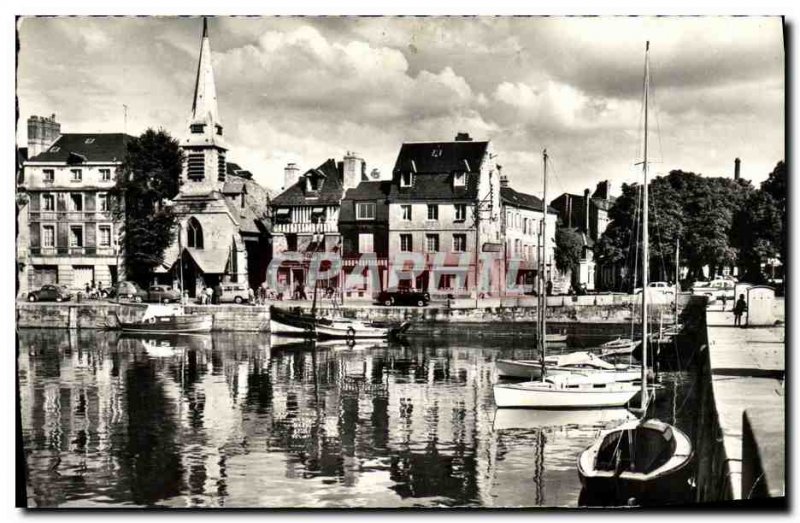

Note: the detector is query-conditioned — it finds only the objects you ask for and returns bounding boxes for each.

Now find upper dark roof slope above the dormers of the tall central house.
[394,141,489,174]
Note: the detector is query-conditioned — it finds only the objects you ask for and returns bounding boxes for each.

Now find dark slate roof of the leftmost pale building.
[29,133,134,162]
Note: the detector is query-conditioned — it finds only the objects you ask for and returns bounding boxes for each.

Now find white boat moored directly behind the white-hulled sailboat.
[495,351,642,381]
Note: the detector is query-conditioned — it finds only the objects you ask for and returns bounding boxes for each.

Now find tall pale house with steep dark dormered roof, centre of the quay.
[388,133,503,296]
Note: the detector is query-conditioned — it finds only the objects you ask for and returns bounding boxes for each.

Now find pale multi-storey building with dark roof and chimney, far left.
[18,116,131,291]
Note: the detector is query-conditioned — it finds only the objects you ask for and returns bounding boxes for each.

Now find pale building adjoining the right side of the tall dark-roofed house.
[500,176,558,289]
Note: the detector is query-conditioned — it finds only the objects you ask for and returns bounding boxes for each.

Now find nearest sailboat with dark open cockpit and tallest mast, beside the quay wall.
[578,41,693,503]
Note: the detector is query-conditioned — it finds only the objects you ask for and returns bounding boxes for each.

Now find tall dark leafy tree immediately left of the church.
[110,129,183,285]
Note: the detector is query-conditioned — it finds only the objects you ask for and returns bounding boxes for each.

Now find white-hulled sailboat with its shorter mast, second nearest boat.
[492,150,639,409]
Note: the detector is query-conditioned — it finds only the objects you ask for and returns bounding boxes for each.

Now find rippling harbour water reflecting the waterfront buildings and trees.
[19,330,683,507]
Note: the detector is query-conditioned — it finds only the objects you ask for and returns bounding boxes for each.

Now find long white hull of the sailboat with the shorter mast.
[493,381,639,409]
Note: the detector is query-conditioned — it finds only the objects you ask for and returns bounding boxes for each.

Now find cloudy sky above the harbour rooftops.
[17,17,785,199]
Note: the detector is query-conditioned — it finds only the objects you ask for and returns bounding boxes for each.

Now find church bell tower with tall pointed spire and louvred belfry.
[181,17,227,194]
